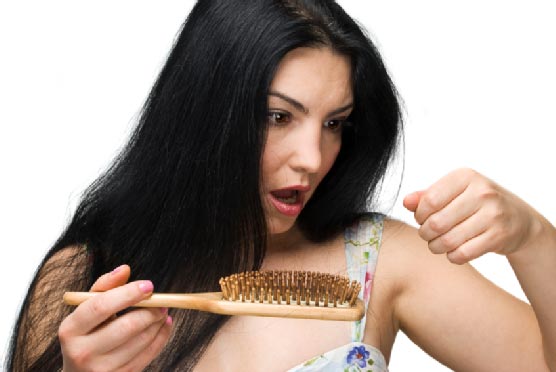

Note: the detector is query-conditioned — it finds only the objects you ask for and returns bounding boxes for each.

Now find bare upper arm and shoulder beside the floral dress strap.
[383,221,548,371]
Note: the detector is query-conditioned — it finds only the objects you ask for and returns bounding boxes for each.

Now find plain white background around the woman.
[0,0,556,371]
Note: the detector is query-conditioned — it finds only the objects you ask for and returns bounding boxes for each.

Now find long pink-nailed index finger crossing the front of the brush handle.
[59,280,153,339]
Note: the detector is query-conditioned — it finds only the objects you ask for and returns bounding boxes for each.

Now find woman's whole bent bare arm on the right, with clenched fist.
[395,169,556,371]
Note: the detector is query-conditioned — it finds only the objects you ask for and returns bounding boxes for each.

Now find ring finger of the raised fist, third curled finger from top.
[429,211,488,254]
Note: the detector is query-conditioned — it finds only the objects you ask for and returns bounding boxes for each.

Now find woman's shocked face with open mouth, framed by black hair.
[262,48,353,234]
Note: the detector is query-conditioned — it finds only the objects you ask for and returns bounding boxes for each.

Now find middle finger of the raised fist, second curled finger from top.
[419,188,480,241]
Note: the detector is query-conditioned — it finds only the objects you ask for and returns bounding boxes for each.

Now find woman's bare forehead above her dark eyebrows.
[271,47,352,105]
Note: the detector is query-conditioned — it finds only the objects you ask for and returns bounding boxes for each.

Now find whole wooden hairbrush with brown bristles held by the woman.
[64,271,365,321]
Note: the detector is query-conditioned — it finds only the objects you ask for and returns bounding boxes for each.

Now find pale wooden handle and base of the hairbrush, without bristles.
[64,292,365,321]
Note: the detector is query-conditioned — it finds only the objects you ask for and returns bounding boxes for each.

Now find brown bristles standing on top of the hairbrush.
[219,271,361,307]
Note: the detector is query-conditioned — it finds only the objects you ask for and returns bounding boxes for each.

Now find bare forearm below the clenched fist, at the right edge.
[508,216,556,371]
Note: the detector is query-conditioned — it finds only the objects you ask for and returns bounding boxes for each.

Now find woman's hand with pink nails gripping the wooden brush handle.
[58,265,172,372]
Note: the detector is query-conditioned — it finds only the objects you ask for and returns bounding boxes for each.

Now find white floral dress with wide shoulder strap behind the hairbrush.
[288,214,388,372]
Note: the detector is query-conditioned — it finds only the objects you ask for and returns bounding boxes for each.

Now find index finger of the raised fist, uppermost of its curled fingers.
[415,170,472,225]
